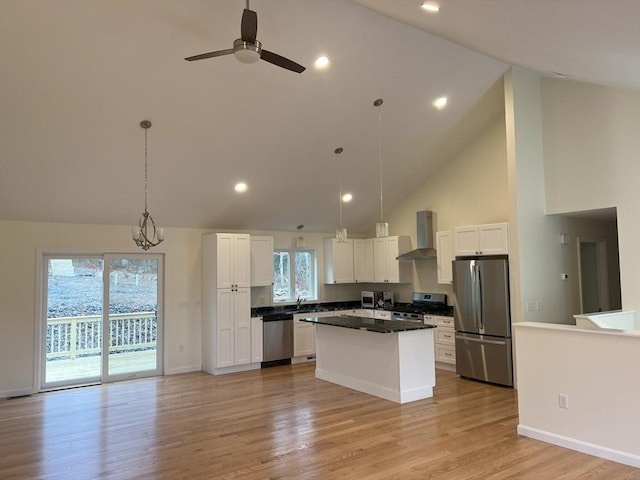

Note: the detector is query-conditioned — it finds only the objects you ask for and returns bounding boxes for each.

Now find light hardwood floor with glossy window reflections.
[0,363,640,480]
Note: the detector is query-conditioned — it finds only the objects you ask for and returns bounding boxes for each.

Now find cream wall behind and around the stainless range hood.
[387,117,508,302]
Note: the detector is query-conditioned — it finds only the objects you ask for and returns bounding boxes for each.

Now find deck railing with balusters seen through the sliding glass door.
[46,312,158,359]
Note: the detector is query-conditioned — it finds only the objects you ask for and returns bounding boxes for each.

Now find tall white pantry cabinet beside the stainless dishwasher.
[202,233,252,374]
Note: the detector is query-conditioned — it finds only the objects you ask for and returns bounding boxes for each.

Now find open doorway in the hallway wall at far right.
[578,237,610,313]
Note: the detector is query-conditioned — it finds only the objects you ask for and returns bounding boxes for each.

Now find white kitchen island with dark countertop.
[301,316,436,403]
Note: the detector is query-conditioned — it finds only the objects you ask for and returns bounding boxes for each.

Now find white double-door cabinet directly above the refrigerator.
[454,223,509,256]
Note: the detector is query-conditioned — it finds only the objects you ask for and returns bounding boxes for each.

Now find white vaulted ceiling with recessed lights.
[0,0,640,233]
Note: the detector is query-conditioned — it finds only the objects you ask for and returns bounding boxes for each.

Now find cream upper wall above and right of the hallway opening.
[541,78,640,311]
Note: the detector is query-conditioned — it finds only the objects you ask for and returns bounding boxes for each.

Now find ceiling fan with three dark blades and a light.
[185,0,305,73]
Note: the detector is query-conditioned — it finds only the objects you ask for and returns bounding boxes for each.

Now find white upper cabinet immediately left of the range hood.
[373,236,413,283]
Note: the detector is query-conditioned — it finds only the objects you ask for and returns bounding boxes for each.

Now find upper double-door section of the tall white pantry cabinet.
[212,233,251,288]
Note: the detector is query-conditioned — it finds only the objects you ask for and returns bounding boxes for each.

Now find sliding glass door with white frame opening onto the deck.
[38,254,164,390]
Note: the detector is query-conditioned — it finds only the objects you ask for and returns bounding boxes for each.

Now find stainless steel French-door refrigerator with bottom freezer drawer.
[453,257,513,386]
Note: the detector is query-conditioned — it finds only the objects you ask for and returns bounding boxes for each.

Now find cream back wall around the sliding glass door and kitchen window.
[0,221,360,397]
